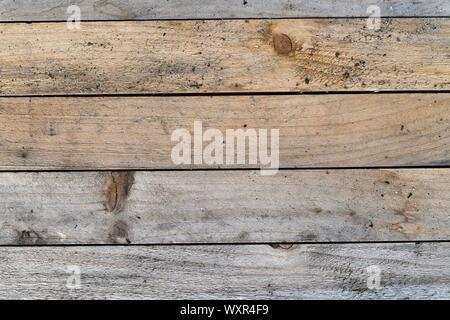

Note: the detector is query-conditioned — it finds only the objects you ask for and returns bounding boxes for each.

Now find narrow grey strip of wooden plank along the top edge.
[0,0,450,21]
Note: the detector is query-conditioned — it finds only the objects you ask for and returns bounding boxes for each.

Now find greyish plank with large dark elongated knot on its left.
[0,169,450,245]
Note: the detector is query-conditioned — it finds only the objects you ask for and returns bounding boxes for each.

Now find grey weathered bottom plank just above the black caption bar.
[0,243,450,299]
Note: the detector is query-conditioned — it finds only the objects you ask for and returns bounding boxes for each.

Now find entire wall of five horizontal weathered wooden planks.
[0,0,450,299]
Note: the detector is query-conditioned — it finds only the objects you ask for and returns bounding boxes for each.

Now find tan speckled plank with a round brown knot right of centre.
[0,18,450,95]
